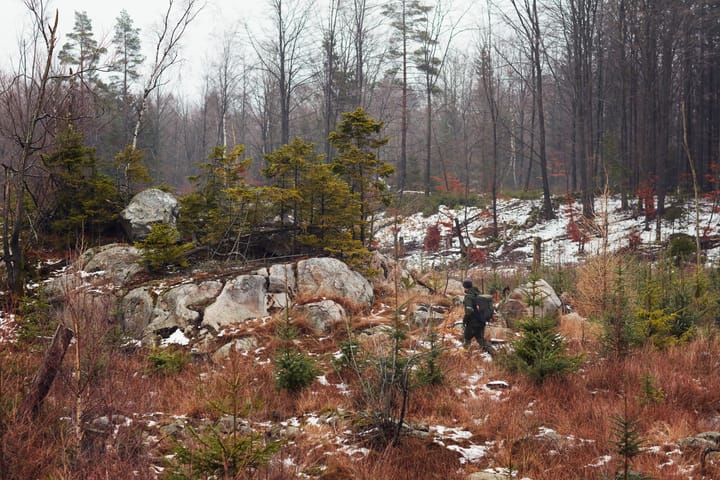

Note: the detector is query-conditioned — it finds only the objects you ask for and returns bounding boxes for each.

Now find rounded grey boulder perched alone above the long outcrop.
[120,188,178,241]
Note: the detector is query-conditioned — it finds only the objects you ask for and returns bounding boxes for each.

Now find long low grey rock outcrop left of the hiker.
[41,244,373,348]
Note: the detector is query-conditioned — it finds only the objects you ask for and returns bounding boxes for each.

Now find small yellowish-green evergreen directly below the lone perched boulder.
[135,222,193,272]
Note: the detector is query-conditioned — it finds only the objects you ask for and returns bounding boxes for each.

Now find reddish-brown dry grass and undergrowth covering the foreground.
[0,278,720,480]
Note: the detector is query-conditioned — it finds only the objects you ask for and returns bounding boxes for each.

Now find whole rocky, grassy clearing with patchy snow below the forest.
[0,193,720,480]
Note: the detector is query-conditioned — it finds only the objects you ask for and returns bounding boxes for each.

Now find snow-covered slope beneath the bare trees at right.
[375,197,720,270]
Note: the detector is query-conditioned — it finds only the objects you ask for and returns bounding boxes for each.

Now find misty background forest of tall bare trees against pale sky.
[0,0,720,289]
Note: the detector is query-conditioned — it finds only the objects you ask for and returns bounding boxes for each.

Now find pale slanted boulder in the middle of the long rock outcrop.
[202,275,268,330]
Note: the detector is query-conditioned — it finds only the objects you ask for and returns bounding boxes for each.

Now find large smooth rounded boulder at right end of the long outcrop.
[297,258,374,306]
